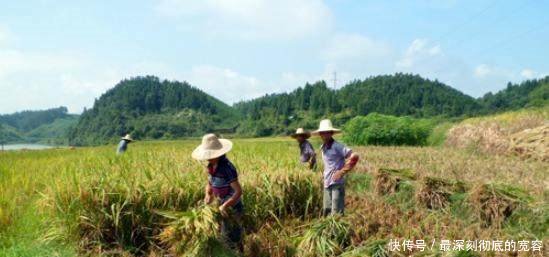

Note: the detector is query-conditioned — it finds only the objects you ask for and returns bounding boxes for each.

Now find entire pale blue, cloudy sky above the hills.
[0,0,549,113]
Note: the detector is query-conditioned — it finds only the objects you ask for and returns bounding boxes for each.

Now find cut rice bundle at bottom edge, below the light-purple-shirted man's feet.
[298,215,352,257]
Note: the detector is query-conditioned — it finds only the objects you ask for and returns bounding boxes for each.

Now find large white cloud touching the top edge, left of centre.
[156,0,333,39]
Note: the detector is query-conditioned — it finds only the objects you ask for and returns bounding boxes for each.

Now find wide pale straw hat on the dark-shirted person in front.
[192,134,233,161]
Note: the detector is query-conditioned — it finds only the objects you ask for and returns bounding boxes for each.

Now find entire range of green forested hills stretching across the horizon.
[8,73,549,145]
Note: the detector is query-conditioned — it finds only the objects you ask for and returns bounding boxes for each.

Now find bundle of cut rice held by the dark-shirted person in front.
[158,206,236,257]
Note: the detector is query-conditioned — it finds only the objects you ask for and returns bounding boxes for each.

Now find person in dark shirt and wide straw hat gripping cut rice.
[192,134,244,252]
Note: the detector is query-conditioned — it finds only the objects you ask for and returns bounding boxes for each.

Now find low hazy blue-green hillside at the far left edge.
[0,107,79,144]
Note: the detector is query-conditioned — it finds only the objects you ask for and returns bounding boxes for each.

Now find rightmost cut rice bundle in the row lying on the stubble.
[470,184,531,227]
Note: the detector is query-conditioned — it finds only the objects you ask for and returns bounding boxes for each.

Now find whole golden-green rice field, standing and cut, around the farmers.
[0,138,549,256]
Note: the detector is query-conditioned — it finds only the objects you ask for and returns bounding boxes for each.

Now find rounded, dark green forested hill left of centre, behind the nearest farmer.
[69,76,239,145]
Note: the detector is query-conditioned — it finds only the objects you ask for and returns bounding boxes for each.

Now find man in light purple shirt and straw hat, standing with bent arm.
[313,120,358,216]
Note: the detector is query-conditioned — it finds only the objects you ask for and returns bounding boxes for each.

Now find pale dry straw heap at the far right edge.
[509,124,549,161]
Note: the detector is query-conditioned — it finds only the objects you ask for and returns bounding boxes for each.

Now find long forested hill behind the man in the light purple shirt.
[234,73,480,136]
